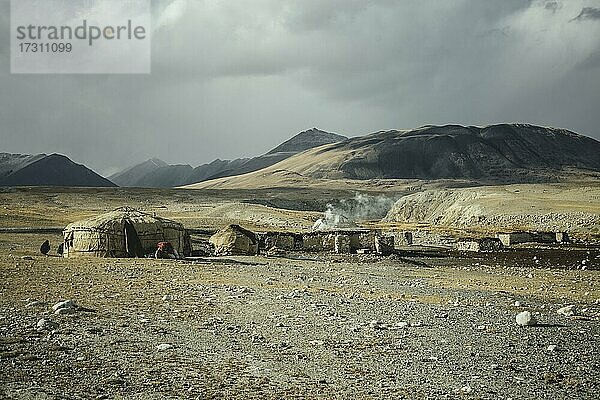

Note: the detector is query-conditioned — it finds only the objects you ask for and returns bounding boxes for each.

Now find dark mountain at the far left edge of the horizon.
[0,153,115,187]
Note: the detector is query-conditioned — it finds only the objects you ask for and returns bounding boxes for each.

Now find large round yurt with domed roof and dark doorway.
[63,207,192,257]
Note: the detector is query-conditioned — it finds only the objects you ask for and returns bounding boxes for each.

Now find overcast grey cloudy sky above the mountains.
[0,0,600,175]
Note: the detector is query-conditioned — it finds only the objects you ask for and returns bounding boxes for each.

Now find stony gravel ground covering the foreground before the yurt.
[0,235,600,399]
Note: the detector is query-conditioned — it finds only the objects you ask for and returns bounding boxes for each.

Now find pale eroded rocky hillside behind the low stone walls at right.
[383,183,600,235]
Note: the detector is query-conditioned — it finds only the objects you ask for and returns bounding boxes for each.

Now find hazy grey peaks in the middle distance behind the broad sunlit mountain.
[110,128,347,187]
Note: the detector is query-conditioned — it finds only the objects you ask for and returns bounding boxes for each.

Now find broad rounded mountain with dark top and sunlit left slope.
[184,124,600,188]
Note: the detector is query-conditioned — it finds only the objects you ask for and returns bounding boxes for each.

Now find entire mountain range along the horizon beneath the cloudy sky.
[0,124,600,189]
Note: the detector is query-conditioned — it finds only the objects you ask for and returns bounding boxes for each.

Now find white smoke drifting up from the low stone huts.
[312,193,397,231]
